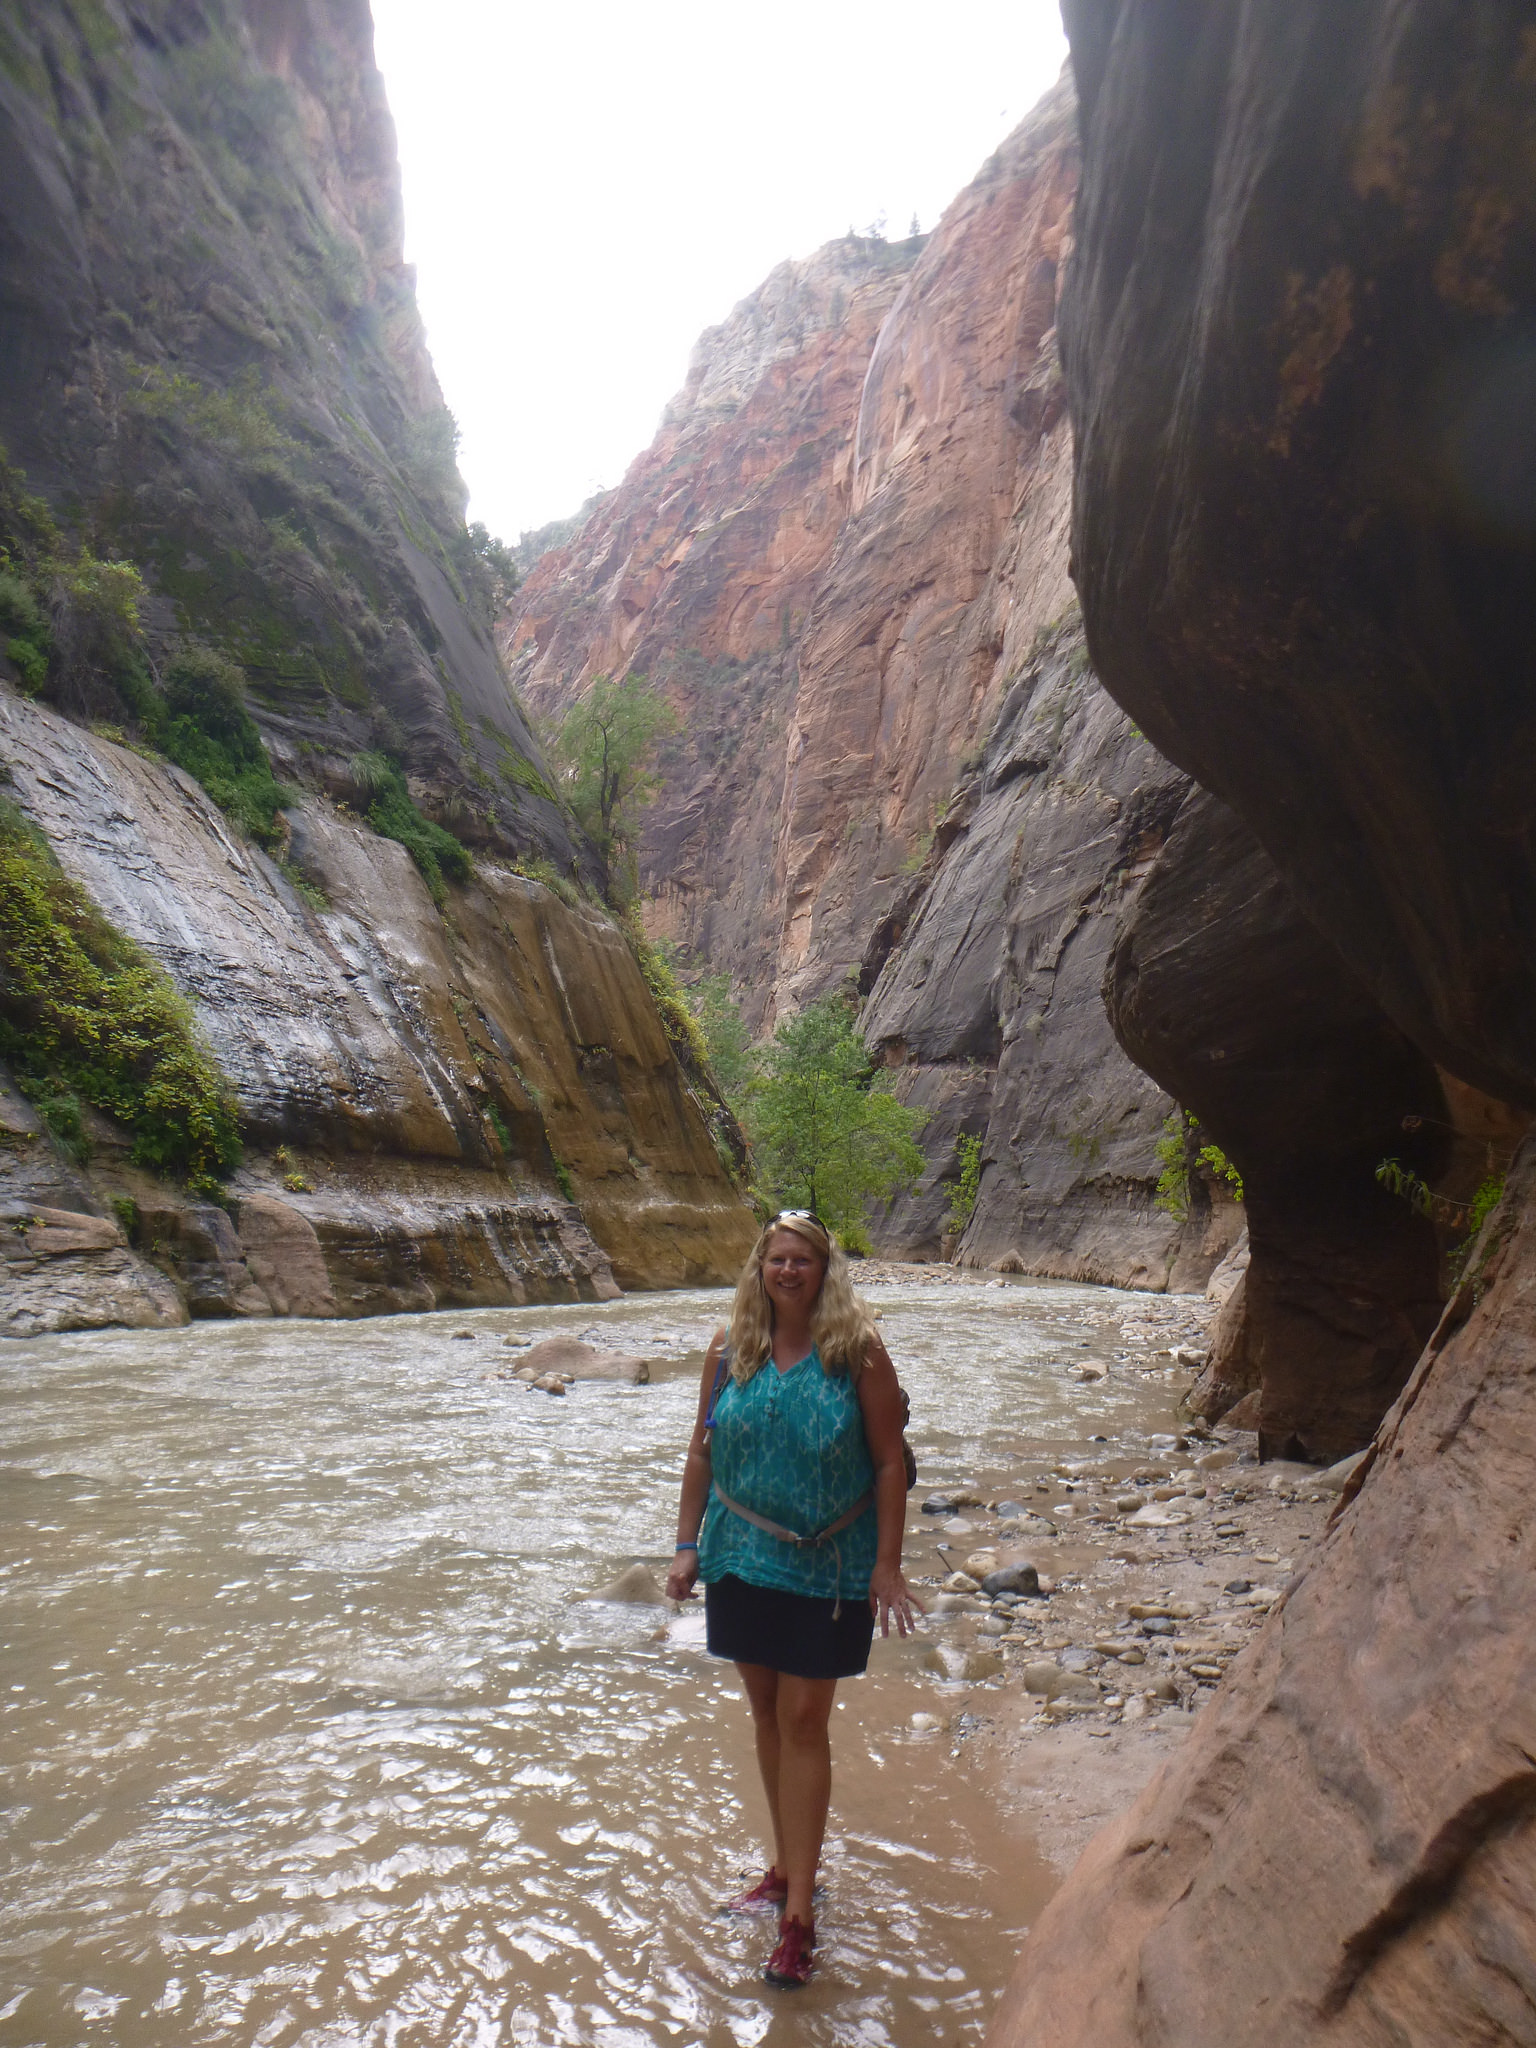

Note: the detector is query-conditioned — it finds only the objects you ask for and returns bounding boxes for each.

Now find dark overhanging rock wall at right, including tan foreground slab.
[991,0,1536,2048]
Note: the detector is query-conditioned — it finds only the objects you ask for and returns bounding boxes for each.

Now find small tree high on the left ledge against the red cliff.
[553,676,678,895]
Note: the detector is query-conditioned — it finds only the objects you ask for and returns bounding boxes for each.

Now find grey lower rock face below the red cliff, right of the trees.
[864,627,1237,1288]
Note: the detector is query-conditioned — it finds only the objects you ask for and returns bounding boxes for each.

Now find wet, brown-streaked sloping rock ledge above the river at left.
[0,686,754,1331]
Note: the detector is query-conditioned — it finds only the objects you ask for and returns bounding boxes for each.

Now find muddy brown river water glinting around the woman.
[0,1284,1196,2048]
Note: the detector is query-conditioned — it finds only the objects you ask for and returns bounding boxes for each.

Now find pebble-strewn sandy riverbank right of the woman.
[872,1262,1348,1874]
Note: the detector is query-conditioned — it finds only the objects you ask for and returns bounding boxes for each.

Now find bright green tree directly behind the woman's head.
[748,995,928,1251]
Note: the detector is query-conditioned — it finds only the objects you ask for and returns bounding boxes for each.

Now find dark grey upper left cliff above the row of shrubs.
[0,0,582,856]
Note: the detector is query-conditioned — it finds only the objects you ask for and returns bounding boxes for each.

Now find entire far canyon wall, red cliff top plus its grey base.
[512,82,1237,1286]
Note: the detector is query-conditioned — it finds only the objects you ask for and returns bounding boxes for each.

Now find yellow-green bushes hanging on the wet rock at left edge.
[0,799,240,1190]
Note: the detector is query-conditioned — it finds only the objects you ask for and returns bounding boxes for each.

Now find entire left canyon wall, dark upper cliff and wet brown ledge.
[0,0,754,1335]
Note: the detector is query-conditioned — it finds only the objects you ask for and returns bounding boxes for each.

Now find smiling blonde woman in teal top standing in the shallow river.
[668,1210,913,1987]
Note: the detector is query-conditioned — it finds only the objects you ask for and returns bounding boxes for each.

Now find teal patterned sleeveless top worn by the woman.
[698,1350,877,1599]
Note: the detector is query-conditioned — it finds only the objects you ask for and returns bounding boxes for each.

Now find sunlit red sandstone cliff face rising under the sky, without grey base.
[504,84,1075,1020]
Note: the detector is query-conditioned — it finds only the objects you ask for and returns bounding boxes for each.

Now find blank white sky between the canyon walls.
[373,0,1067,541]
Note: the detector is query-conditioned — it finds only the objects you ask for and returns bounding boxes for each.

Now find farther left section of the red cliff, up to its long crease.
[502,238,922,1024]
